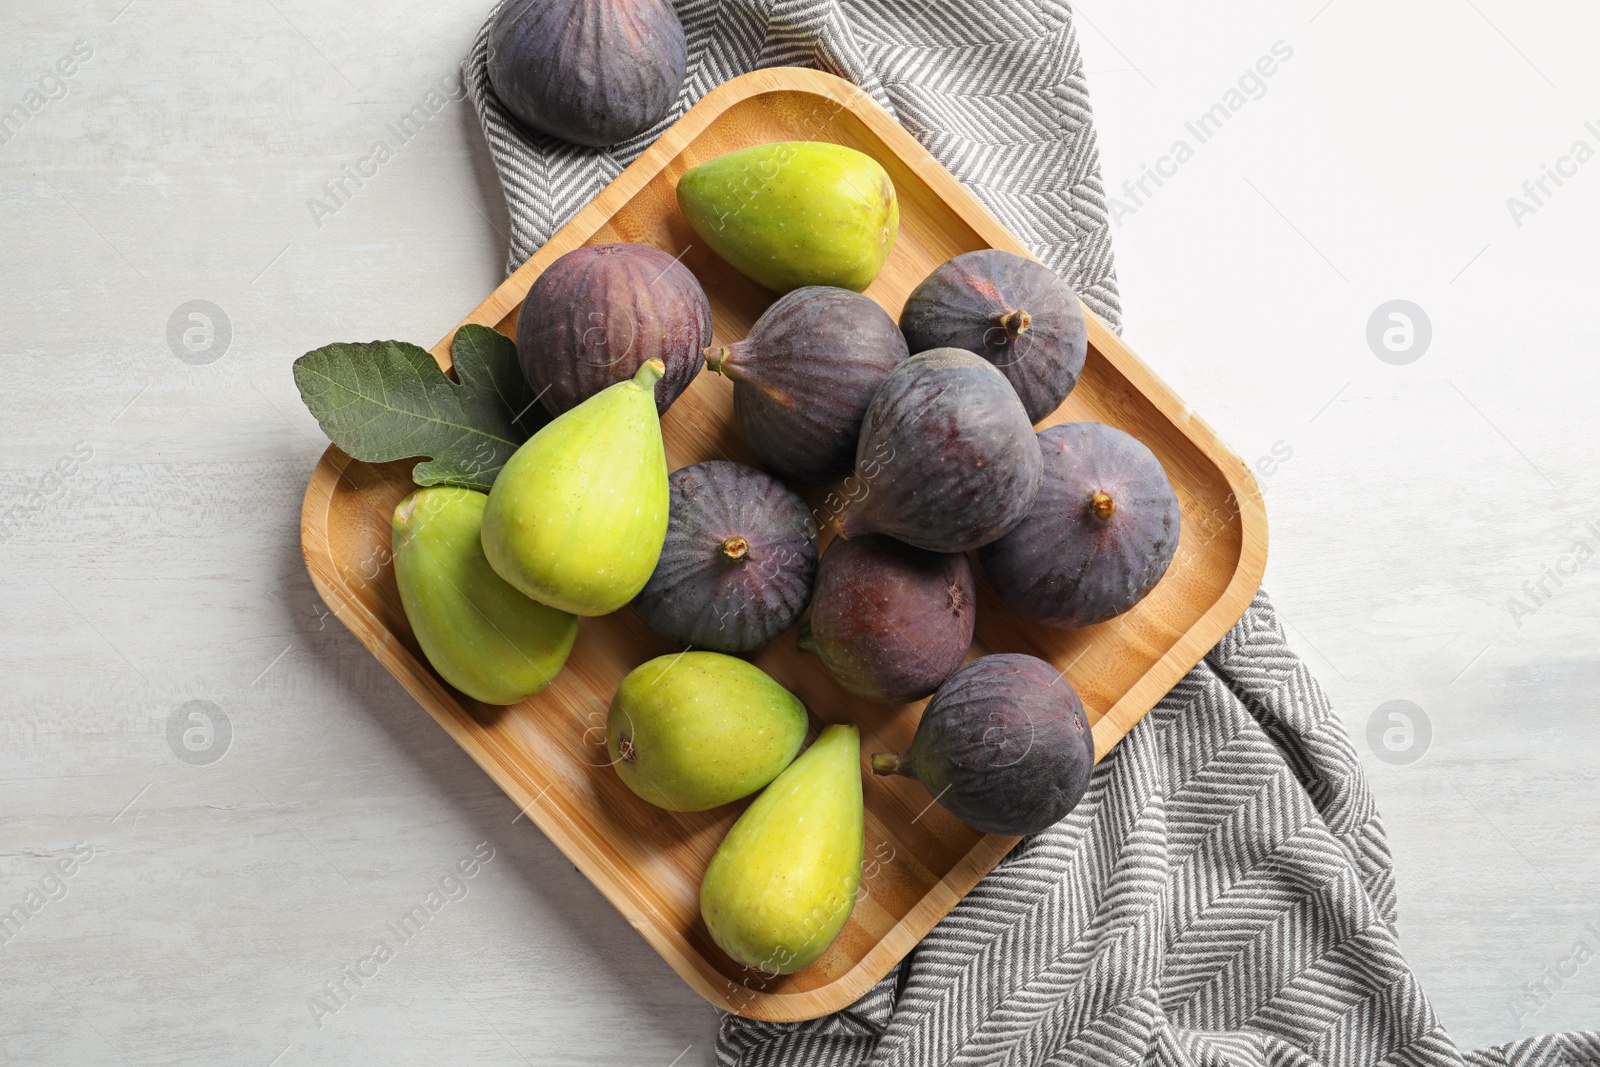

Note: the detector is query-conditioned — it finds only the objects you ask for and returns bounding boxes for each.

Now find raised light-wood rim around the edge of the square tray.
[301,67,1267,1022]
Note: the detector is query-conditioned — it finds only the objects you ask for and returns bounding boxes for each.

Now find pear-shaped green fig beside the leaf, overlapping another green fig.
[483,360,667,616]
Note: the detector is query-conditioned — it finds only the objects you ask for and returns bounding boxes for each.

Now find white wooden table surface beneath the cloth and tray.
[0,0,1600,1067]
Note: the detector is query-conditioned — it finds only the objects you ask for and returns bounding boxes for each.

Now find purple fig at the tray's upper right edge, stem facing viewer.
[901,248,1088,422]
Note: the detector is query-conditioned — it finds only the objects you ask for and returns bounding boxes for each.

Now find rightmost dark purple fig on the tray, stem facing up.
[978,422,1181,627]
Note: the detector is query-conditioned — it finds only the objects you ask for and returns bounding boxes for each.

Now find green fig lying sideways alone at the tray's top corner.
[678,141,899,293]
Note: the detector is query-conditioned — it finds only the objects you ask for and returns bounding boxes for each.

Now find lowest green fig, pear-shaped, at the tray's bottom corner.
[701,726,866,974]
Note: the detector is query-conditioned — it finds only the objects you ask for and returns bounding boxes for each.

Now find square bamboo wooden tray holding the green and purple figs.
[301,69,1267,1021]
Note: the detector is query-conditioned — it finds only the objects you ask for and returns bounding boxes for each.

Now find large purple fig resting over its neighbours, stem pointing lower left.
[843,349,1040,552]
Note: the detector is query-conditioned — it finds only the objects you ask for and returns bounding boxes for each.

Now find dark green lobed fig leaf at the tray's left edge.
[294,323,549,491]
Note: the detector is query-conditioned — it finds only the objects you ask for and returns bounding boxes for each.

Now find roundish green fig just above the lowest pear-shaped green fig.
[605,653,806,811]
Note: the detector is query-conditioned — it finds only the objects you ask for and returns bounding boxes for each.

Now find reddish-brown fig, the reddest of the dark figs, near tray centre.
[800,534,978,704]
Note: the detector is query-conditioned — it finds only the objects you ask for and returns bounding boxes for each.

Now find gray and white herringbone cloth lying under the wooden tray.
[466,0,1600,1067]
